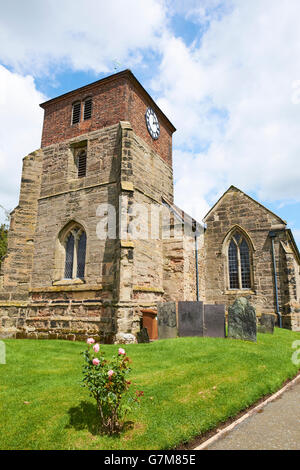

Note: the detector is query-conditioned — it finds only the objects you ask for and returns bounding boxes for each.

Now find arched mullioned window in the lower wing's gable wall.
[228,232,251,289]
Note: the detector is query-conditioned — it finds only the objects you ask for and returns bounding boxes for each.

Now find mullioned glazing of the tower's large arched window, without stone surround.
[64,226,86,279]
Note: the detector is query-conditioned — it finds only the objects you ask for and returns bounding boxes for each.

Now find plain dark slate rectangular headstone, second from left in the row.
[178,302,203,336]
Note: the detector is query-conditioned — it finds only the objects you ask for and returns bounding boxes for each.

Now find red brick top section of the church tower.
[40,70,176,166]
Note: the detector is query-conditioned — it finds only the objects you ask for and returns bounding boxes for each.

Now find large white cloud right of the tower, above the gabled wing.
[156,0,300,220]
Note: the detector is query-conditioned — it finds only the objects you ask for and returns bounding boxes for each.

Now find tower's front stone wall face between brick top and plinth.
[32,126,118,288]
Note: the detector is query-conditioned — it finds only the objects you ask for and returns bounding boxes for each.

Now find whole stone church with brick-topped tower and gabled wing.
[0,70,300,343]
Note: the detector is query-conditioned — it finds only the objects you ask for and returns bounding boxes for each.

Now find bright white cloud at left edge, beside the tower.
[0,65,46,220]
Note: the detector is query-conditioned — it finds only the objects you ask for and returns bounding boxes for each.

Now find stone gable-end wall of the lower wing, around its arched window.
[205,187,284,312]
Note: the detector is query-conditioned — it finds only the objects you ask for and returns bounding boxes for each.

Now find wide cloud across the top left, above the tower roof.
[0,0,165,75]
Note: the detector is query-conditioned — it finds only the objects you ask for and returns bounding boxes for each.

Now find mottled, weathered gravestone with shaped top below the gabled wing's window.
[228,297,256,341]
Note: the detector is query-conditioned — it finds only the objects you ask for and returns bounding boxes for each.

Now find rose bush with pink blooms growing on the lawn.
[83,338,143,434]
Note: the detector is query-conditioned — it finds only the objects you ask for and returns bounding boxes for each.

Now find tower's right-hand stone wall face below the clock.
[113,119,173,334]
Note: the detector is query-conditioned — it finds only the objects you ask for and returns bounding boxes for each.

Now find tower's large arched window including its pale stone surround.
[54,221,87,281]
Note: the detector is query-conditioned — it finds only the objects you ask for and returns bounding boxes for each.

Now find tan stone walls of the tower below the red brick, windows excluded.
[1,117,173,342]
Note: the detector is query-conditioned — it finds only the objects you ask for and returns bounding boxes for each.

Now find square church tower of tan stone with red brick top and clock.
[0,70,195,342]
